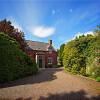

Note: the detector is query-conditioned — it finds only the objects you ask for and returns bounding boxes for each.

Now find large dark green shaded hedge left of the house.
[0,33,38,83]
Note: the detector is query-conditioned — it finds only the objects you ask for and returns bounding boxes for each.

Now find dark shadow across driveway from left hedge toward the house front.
[0,68,63,88]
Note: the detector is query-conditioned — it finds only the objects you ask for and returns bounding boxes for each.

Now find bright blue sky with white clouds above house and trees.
[0,0,100,48]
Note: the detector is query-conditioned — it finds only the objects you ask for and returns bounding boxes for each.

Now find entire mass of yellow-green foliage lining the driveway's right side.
[63,26,100,80]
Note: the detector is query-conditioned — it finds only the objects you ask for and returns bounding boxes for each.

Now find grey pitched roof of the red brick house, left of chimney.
[26,40,54,51]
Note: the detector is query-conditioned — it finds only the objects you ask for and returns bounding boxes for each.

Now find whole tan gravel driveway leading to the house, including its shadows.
[0,68,100,100]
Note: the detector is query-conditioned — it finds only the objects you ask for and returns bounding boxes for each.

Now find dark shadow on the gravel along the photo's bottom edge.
[2,90,100,100]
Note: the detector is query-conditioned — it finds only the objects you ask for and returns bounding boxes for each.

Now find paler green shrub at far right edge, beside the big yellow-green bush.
[87,26,100,81]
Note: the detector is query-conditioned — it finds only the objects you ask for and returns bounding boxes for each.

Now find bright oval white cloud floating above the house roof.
[31,26,55,38]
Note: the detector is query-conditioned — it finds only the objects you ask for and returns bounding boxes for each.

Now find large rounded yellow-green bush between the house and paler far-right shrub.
[63,35,96,75]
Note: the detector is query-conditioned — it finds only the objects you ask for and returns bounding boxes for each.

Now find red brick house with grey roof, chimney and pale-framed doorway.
[27,40,57,68]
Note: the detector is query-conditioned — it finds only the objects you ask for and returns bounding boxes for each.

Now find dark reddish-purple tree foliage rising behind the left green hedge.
[0,19,27,51]
